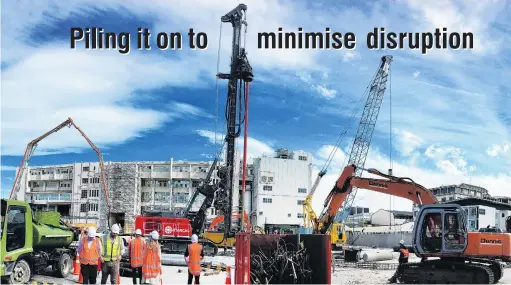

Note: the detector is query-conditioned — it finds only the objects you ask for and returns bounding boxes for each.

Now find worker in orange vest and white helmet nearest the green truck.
[76,227,101,284]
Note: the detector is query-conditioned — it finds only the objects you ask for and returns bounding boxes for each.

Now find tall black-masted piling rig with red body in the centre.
[132,4,254,253]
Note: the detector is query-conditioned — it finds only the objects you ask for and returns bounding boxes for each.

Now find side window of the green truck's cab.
[2,205,26,252]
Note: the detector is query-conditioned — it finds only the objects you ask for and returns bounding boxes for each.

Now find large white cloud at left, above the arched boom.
[1,45,216,155]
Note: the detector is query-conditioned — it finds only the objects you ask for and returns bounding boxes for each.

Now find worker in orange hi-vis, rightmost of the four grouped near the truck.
[142,231,162,285]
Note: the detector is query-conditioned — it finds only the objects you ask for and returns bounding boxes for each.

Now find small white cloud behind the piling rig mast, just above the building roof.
[197,130,274,163]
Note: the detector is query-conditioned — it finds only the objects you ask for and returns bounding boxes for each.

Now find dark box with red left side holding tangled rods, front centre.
[235,233,332,284]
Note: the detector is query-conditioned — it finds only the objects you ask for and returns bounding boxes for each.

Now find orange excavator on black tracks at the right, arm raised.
[313,165,511,284]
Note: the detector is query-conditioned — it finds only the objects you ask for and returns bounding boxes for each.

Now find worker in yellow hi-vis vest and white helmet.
[101,224,124,284]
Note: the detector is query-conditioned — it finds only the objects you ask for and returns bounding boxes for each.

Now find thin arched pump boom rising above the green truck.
[9,118,111,225]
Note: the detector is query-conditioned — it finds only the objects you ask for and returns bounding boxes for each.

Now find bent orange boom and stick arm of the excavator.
[314,165,438,234]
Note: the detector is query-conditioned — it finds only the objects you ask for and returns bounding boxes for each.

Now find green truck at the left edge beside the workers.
[0,199,79,284]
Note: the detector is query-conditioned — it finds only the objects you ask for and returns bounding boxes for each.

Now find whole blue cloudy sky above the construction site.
[1,0,511,210]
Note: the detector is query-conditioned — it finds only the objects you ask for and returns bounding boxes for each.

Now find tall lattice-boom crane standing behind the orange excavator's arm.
[303,55,392,234]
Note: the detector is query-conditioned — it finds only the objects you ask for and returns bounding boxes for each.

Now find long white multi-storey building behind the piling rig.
[18,148,312,232]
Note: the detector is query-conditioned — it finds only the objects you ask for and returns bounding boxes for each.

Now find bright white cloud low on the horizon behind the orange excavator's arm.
[312,146,511,213]
